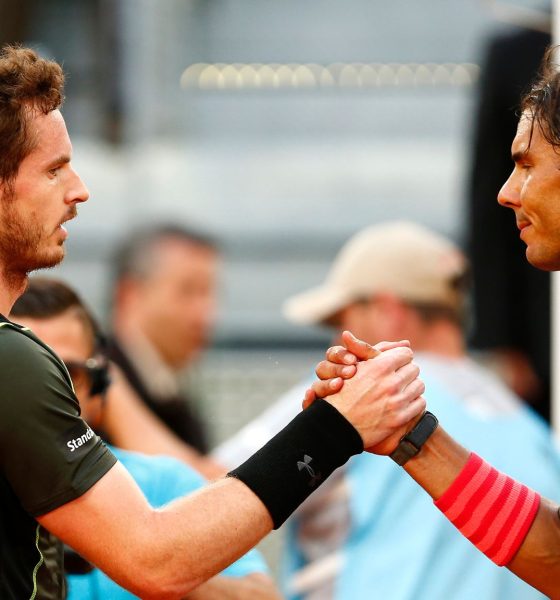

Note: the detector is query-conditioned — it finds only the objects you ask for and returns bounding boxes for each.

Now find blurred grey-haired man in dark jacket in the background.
[109,225,218,452]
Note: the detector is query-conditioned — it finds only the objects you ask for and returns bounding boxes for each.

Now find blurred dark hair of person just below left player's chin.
[10,277,102,350]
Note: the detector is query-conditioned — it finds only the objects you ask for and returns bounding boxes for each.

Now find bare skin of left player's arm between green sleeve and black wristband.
[37,463,272,600]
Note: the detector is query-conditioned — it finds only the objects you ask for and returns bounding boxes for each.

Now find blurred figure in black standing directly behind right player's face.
[467,29,550,419]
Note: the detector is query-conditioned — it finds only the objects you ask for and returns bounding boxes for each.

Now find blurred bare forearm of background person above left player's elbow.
[102,365,225,479]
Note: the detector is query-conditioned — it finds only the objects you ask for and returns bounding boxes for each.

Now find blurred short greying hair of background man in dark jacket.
[113,223,218,283]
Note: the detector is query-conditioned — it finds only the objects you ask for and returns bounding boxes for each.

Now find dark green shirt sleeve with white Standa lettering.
[0,326,116,517]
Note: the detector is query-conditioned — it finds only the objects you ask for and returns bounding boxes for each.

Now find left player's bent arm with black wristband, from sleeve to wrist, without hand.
[39,402,363,600]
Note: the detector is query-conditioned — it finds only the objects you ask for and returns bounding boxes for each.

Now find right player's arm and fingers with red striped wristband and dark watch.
[305,332,560,599]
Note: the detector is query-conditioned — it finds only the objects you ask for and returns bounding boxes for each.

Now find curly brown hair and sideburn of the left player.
[0,46,64,187]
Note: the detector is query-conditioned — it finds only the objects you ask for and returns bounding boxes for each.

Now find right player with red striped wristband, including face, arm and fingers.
[304,48,560,599]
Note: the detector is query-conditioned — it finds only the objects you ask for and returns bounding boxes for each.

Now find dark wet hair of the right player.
[521,46,560,150]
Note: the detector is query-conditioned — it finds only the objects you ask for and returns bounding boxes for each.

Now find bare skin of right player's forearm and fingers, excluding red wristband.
[316,332,560,600]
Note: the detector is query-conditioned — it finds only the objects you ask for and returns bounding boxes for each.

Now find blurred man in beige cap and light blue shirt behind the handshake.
[212,222,560,600]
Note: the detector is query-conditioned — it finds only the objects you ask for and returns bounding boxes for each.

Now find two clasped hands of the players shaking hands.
[303,331,426,454]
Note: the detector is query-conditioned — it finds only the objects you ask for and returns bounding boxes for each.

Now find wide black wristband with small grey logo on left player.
[228,400,364,529]
